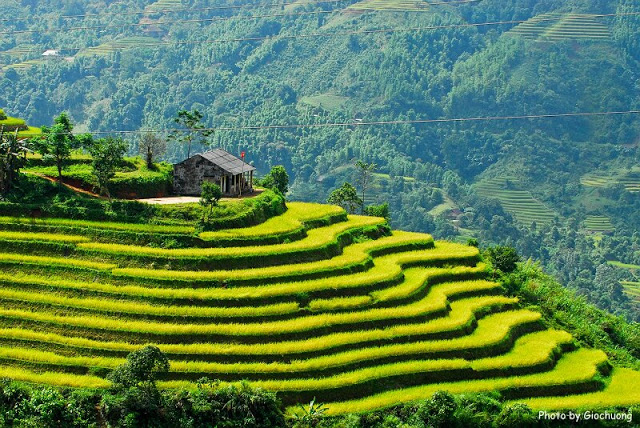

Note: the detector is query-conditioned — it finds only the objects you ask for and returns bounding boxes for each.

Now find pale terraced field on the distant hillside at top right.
[509,13,611,42]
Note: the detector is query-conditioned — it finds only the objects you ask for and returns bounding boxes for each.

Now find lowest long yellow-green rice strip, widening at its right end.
[325,349,606,415]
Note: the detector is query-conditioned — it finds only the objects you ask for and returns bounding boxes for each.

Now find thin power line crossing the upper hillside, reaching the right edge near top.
[10,12,640,52]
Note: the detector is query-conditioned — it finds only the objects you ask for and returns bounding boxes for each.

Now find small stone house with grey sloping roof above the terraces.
[173,149,256,196]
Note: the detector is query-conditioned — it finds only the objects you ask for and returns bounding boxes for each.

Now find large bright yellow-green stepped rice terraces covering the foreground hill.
[0,203,640,414]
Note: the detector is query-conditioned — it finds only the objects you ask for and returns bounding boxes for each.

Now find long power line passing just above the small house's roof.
[32,110,640,135]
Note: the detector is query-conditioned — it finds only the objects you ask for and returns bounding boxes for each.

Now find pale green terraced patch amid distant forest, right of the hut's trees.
[476,176,556,226]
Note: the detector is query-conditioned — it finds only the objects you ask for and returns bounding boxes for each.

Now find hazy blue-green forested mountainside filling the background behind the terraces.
[0,0,640,319]
